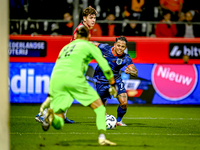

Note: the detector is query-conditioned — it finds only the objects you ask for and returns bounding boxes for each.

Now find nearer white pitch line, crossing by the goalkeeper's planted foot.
[10,132,200,136]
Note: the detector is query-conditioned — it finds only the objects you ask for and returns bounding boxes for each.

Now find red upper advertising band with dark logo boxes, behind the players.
[9,35,200,64]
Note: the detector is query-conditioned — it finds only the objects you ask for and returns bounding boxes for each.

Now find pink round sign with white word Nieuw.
[152,64,198,101]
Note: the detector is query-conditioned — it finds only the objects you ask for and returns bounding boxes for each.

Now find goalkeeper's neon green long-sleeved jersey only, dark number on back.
[53,39,113,80]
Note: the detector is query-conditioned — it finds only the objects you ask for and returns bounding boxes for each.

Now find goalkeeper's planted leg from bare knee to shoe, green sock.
[90,99,117,145]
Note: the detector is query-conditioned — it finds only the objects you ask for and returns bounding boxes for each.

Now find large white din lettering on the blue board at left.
[9,69,50,94]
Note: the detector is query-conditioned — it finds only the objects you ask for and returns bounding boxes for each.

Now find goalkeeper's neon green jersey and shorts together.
[49,39,113,113]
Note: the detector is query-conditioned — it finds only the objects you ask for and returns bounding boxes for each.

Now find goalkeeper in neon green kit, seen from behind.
[41,25,117,145]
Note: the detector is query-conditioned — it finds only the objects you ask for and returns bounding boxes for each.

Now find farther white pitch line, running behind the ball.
[10,116,200,120]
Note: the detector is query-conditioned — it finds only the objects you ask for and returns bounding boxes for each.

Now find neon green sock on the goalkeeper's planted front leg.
[94,105,106,131]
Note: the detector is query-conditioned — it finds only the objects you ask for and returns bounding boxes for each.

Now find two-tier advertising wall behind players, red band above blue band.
[8,36,200,105]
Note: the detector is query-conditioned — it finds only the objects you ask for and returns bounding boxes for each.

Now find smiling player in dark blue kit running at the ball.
[92,36,138,126]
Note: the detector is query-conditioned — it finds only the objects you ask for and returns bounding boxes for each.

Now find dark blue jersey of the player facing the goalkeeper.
[94,44,133,83]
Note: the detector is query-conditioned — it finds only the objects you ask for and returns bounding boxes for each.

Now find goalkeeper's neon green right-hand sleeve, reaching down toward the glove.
[90,43,114,80]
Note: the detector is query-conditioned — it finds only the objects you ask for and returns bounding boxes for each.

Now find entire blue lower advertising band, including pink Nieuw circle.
[9,62,200,105]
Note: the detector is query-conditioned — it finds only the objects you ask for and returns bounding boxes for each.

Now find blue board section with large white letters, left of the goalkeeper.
[9,63,54,103]
